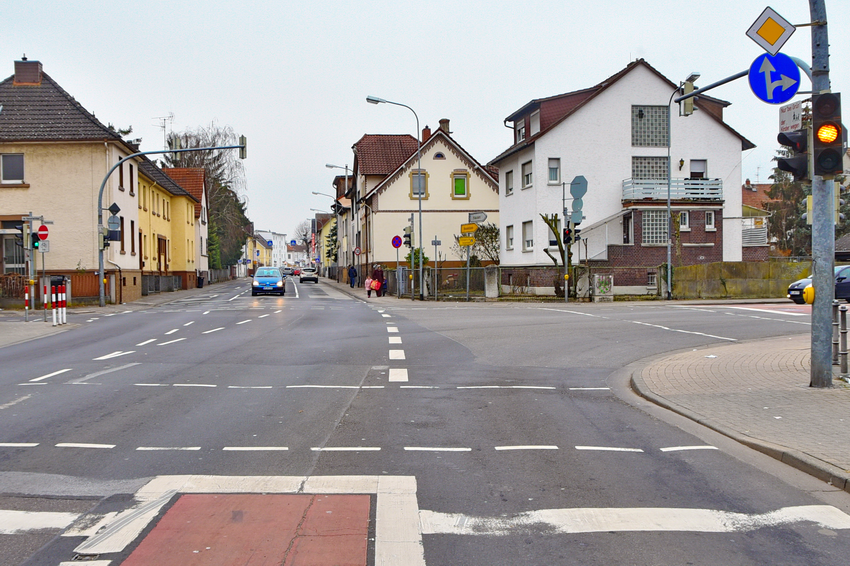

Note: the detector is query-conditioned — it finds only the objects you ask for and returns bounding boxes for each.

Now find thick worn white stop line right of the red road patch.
[419,505,850,536]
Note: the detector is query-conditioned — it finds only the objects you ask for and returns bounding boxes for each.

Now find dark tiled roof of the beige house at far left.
[0,69,126,144]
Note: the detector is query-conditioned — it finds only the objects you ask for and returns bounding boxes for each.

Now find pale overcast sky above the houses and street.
[0,0,850,235]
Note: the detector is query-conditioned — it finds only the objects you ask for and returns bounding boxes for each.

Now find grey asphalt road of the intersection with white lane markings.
[0,280,850,565]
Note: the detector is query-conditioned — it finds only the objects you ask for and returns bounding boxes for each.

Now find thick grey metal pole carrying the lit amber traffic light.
[809,0,835,387]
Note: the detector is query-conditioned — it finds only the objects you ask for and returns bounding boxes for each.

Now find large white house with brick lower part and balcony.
[490,59,752,292]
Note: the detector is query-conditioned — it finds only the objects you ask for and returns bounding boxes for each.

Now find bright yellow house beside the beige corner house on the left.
[134,159,198,289]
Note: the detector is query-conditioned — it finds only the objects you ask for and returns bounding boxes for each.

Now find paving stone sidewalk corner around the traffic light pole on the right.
[632,334,850,492]
